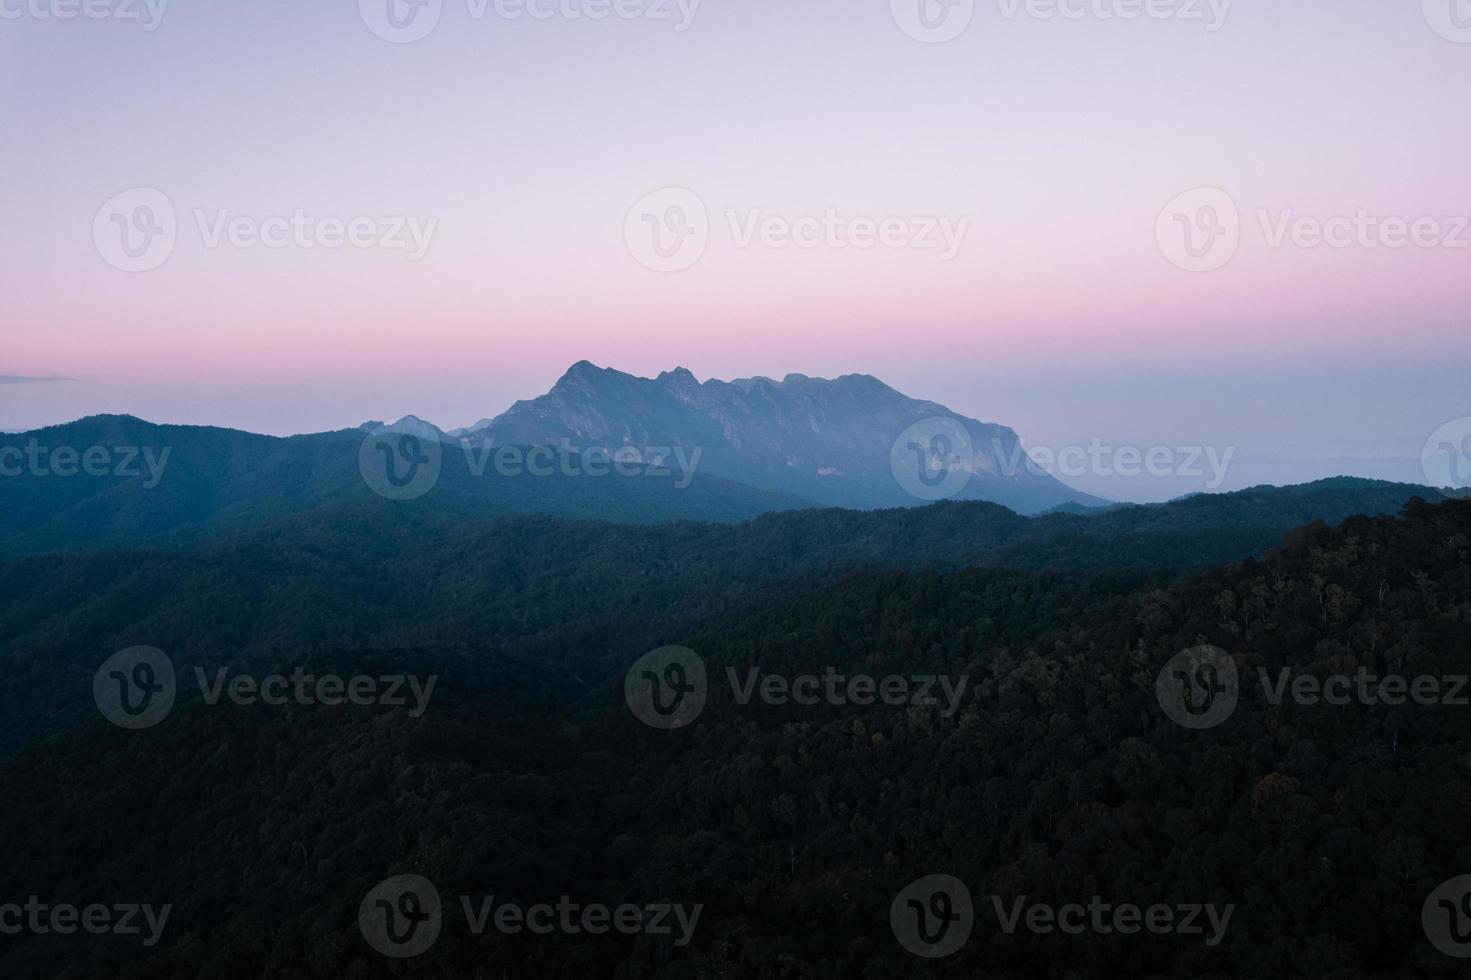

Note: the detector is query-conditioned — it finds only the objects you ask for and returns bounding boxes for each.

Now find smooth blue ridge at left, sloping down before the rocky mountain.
[0,415,811,556]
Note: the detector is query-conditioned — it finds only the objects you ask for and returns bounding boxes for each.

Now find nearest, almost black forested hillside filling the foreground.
[0,502,1471,980]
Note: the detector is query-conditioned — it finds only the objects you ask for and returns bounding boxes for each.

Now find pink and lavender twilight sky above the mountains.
[0,0,1471,497]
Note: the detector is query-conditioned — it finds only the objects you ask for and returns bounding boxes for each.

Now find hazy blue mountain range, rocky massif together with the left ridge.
[0,361,1459,558]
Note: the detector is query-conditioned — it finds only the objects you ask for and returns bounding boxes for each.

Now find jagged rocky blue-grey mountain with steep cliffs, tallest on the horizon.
[463,361,1108,514]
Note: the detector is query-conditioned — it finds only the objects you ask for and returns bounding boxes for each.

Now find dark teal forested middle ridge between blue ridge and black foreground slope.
[0,480,1447,758]
